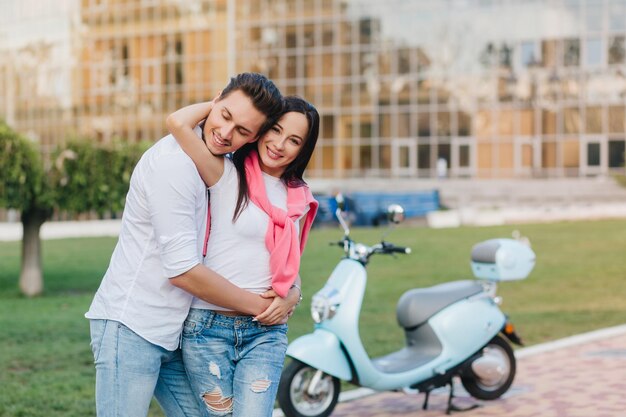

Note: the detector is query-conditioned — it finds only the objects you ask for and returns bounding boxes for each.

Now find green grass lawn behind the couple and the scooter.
[0,220,626,417]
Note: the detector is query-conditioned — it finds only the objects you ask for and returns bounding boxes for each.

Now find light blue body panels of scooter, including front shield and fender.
[287,259,505,391]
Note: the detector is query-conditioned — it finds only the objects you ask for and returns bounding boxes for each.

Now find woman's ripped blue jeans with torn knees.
[182,308,287,417]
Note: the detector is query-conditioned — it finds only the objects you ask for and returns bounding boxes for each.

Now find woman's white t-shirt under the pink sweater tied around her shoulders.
[192,158,299,311]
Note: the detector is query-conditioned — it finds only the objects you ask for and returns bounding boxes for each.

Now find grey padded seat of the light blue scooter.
[396,280,483,330]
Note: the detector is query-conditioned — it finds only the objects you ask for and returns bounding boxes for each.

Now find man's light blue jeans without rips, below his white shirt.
[90,320,202,417]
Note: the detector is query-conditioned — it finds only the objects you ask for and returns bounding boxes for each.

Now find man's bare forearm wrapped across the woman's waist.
[170,264,272,316]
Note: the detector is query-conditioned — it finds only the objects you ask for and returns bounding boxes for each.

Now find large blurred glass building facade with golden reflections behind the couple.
[0,0,626,178]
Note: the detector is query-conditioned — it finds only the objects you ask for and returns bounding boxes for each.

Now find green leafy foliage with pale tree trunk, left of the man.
[0,122,148,297]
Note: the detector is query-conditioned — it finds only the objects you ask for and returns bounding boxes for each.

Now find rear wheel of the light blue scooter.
[461,336,516,400]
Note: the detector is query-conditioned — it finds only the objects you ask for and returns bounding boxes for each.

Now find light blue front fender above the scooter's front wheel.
[287,329,352,381]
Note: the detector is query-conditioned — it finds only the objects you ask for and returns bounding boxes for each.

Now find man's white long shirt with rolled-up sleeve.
[85,128,207,350]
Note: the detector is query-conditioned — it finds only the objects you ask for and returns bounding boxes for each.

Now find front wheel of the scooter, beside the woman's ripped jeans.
[278,360,341,417]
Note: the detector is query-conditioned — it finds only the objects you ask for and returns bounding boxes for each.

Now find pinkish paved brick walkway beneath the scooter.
[276,326,626,417]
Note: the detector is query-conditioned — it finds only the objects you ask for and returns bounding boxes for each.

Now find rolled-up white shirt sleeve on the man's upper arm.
[143,152,200,278]
